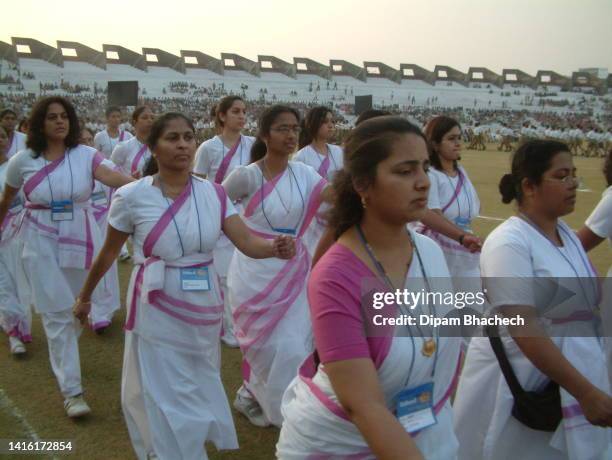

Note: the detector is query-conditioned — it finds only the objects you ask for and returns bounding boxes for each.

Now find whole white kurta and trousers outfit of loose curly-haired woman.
[6,145,103,398]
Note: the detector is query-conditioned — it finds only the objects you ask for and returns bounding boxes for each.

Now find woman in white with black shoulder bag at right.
[454,140,612,460]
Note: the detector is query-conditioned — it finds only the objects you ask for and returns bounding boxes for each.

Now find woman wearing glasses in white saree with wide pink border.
[223,105,327,426]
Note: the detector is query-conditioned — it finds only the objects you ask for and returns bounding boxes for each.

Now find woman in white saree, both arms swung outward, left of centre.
[75,113,294,460]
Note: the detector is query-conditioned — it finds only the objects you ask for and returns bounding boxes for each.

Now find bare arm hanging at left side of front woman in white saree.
[74,225,130,324]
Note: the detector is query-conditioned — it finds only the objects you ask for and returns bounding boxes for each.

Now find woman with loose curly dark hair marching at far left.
[0,97,132,417]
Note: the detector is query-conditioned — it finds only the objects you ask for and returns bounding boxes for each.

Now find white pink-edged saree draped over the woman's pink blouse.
[277,234,460,460]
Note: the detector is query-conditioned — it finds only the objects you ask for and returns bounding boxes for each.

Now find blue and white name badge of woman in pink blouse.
[396,382,438,434]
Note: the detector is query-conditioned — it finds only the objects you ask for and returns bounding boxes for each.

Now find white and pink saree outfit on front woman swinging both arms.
[109,177,238,459]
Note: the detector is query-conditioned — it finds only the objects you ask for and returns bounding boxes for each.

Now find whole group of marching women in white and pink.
[0,96,612,460]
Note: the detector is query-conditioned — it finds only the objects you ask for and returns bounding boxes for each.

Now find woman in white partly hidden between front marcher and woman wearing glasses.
[193,96,255,347]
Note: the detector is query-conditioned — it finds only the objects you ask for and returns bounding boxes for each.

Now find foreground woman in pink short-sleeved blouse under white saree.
[277,117,460,460]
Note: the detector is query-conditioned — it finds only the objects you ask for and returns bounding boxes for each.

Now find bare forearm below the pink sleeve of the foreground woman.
[325,358,423,460]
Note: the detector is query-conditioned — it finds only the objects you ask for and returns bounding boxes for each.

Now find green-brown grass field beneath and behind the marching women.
[0,149,612,460]
